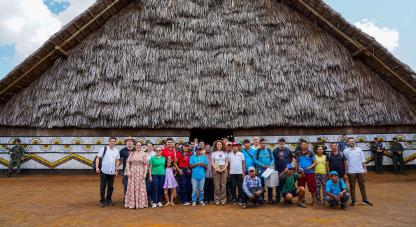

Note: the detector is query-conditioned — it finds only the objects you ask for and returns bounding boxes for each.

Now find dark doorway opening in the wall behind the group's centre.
[189,128,234,145]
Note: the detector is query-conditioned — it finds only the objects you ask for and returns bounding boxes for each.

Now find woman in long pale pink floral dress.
[124,142,148,209]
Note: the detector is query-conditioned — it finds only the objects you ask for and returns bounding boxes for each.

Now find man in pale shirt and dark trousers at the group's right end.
[344,137,373,206]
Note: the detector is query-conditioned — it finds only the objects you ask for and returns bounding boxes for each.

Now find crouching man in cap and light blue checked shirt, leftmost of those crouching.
[241,166,263,209]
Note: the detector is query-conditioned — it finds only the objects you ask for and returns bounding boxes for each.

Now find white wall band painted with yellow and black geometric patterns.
[0,134,416,169]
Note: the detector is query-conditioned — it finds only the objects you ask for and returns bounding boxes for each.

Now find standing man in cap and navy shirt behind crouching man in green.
[273,138,293,203]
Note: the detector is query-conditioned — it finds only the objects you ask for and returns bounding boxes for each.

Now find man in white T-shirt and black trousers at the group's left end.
[95,137,120,207]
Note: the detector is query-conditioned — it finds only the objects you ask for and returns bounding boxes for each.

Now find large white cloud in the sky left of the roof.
[0,0,95,66]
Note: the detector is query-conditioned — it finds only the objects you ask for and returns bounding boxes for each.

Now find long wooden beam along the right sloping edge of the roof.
[296,0,416,100]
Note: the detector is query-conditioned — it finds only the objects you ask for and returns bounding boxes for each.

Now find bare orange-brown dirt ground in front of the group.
[0,171,416,226]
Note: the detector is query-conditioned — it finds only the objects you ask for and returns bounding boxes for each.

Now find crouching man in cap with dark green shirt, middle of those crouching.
[279,164,306,208]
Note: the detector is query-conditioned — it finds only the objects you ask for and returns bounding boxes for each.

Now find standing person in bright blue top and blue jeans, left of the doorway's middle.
[190,147,208,206]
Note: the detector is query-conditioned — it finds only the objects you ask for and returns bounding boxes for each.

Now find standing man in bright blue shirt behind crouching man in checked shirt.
[254,138,274,204]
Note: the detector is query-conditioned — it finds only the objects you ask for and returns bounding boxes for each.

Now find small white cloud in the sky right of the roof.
[354,19,400,51]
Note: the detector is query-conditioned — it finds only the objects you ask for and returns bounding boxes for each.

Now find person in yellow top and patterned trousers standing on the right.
[314,146,328,205]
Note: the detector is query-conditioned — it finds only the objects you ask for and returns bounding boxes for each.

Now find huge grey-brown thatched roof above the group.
[0,0,416,128]
